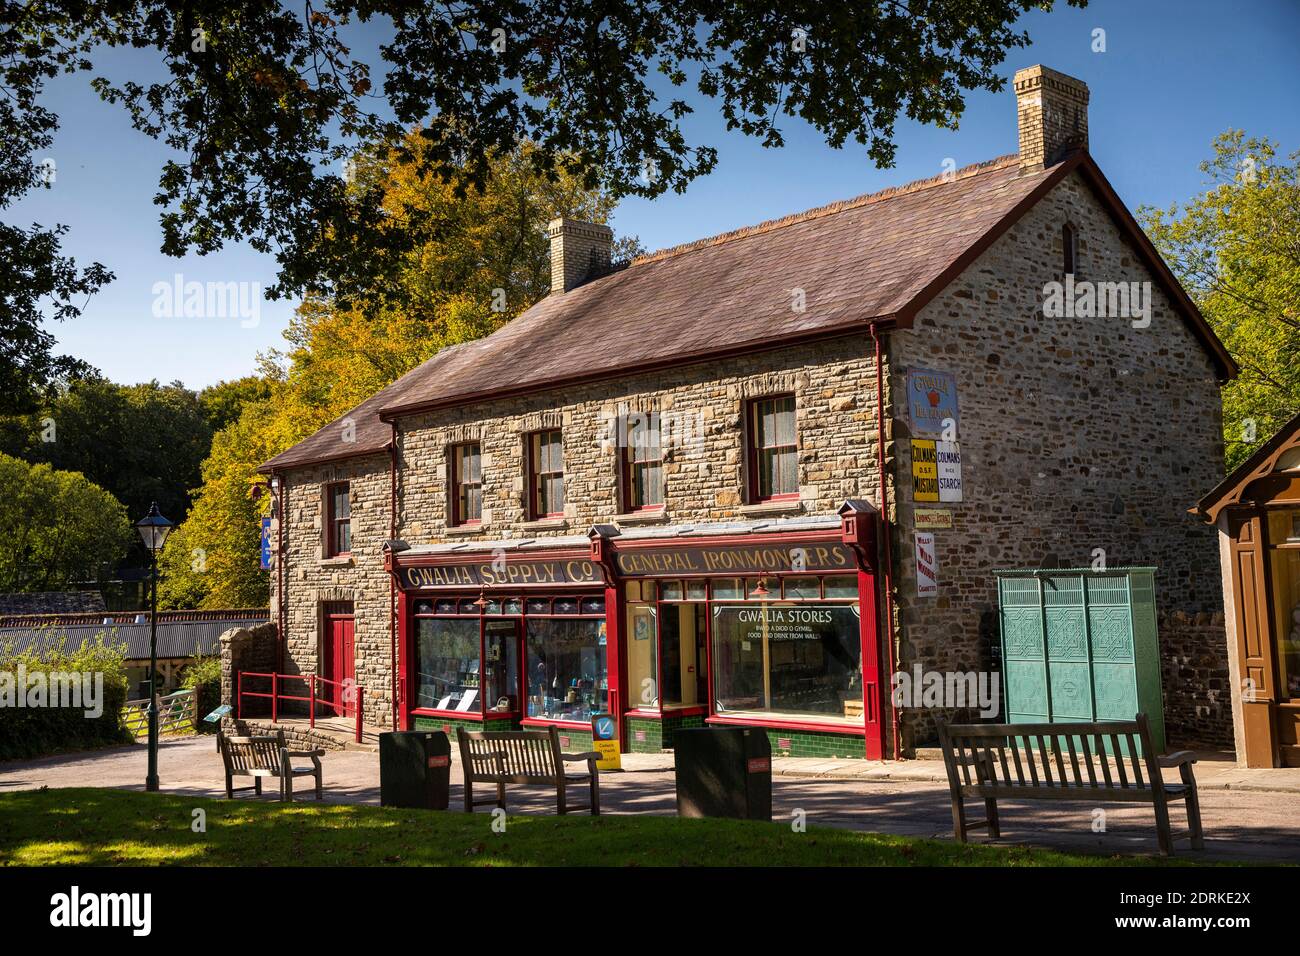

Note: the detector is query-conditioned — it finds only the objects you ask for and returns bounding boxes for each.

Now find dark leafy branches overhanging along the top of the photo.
[0,0,1086,321]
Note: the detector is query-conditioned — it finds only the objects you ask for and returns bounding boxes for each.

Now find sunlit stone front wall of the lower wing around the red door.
[273,453,393,727]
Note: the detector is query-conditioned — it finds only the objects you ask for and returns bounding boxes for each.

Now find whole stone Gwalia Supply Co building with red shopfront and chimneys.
[245,66,1235,757]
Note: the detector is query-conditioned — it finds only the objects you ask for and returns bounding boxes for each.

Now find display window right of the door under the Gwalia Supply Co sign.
[525,618,608,723]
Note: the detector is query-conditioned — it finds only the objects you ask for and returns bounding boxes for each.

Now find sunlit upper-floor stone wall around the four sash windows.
[398,336,878,545]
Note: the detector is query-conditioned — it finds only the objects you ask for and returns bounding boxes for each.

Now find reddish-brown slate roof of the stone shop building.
[263,151,1235,471]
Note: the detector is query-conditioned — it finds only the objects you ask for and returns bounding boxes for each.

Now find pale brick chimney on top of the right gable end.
[1015,65,1088,173]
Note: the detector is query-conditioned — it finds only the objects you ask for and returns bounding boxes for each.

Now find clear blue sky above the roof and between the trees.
[20,0,1300,388]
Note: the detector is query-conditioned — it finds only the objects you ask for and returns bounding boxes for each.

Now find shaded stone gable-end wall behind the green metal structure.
[889,167,1227,743]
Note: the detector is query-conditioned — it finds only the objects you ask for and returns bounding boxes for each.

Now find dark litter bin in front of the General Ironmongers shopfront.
[673,727,772,821]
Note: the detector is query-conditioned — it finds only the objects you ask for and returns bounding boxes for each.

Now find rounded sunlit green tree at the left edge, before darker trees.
[0,454,134,591]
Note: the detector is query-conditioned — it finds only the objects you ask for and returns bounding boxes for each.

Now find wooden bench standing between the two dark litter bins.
[458,727,601,817]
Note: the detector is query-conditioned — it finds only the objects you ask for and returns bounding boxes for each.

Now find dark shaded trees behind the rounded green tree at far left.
[0,375,212,520]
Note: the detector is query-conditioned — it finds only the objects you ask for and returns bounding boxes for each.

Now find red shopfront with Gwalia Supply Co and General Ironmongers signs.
[390,511,881,758]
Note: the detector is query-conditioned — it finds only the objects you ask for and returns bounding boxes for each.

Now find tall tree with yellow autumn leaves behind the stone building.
[160,133,640,607]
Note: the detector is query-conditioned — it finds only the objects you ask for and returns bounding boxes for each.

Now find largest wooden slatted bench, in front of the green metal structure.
[939,714,1205,855]
